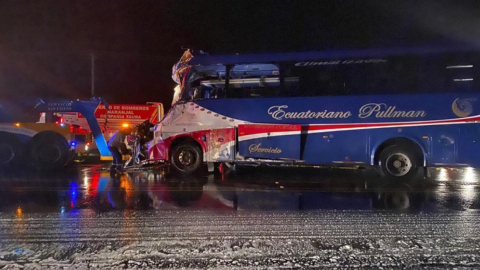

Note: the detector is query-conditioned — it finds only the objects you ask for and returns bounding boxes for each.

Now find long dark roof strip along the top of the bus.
[188,46,479,66]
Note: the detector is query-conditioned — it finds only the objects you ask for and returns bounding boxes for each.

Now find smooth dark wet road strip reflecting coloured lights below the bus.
[0,166,480,215]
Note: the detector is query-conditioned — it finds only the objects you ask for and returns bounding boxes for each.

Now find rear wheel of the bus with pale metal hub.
[379,145,418,180]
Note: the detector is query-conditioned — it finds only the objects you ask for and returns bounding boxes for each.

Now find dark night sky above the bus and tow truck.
[0,0,480,109]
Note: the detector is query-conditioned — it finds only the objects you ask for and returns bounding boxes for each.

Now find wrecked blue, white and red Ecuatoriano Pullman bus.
[149,47,480,180]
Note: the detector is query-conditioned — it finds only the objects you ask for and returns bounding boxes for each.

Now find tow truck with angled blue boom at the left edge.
[0,100,109,170]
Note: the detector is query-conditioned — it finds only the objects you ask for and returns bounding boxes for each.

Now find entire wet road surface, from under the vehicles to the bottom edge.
[0,166,480,269]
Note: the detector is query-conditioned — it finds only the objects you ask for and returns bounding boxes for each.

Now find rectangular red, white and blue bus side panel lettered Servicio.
[238,124,301,160]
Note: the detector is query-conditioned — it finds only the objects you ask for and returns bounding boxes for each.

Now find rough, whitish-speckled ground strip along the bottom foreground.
[0,210,480,269]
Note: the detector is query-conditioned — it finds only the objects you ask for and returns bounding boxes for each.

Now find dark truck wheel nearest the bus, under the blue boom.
[30,131,70,171]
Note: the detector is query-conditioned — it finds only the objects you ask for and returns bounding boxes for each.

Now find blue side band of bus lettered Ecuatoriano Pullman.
[196,93,480,124]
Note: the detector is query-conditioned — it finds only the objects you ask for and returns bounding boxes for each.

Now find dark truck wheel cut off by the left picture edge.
[0,132,22,168]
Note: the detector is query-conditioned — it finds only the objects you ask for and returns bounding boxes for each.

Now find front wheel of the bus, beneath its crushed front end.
[170,143,202,173]
